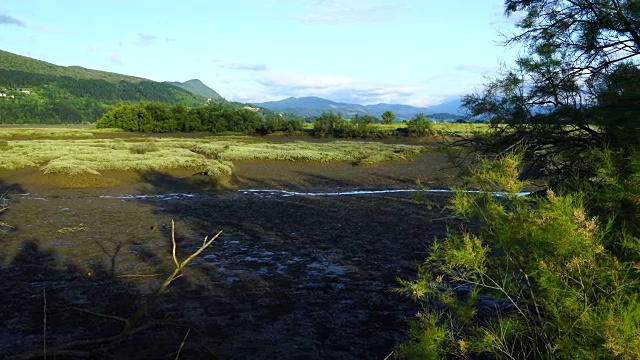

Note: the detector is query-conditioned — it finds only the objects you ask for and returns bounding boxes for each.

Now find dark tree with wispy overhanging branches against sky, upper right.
[463,0,640,182]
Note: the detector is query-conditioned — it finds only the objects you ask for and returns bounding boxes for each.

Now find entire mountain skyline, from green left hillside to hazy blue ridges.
[0,50,462,124]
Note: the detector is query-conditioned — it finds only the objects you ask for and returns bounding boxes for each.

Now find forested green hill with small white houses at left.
[0,50,205,124]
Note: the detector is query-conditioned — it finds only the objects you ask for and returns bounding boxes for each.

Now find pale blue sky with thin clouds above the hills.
[0,0,516,106]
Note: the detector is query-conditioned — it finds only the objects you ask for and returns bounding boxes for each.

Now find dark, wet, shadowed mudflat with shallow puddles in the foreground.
[0,155,460,359]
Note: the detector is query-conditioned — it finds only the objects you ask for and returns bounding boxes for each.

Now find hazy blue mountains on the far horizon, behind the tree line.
[253,97,463,120]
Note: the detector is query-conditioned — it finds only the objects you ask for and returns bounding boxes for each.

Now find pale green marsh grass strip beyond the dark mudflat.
[0,134,426,183]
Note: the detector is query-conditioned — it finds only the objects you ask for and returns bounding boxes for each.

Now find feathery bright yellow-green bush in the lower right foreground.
[399,154,640,359]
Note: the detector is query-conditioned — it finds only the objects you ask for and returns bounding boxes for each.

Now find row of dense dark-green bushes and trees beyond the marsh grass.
[96,102,435,138]
